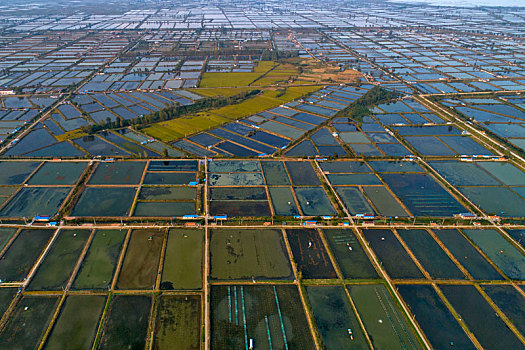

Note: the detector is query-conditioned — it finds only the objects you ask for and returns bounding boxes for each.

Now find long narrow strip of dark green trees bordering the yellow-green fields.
[81,89,260,134]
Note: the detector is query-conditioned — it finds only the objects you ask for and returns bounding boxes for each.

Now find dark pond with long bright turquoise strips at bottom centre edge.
[211,285,315,350]
